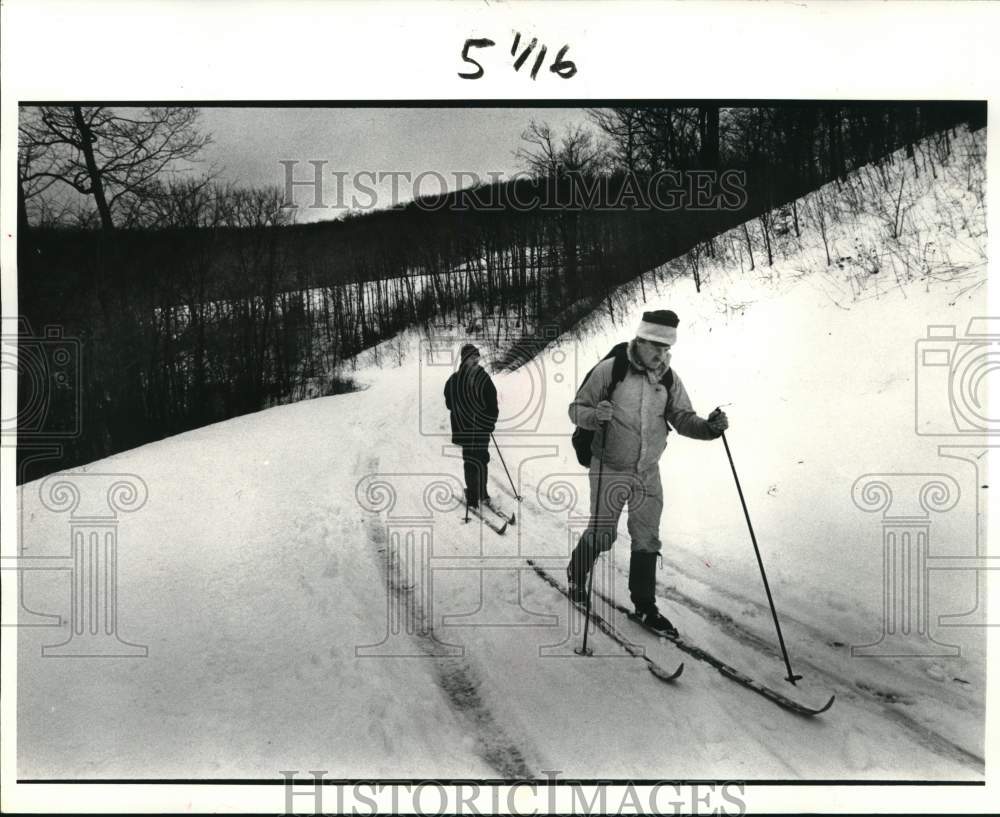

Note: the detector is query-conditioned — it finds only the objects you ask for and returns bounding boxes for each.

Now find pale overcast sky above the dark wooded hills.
[193,108,587,223]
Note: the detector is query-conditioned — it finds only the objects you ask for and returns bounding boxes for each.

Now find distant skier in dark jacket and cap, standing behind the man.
[444,343,500,508]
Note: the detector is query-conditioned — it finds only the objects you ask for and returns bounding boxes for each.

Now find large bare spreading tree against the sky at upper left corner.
[18,105,211,230]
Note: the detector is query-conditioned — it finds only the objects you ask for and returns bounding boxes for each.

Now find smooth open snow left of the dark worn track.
[18,395,495,779]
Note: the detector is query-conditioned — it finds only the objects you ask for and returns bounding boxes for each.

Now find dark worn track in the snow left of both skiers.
[366,460,535,780]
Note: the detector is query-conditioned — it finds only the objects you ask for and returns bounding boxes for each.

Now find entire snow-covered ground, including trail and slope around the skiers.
[17,126,989,780]
